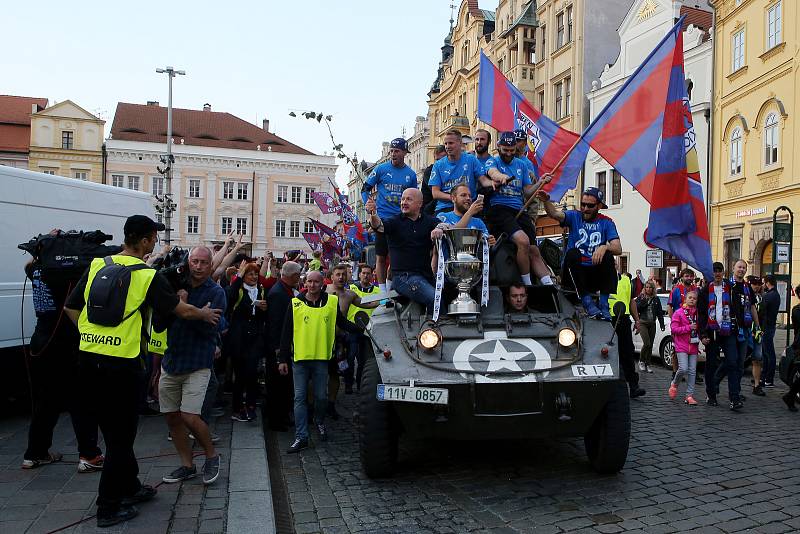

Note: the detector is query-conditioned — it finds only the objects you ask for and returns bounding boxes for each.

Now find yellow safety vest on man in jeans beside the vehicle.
[292,295,339,362]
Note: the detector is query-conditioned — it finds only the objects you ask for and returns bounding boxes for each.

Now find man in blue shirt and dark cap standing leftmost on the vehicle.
[354,137,417,293]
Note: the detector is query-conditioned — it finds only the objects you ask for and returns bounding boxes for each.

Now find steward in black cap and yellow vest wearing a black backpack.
[64,215,222,527]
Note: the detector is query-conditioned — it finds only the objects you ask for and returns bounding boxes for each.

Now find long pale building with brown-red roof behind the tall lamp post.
[106,102,336,255]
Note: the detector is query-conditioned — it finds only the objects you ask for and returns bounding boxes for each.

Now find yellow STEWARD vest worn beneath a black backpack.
[78,255,156,358]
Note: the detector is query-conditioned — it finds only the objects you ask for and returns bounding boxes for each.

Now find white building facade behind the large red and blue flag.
[585,0,713,288]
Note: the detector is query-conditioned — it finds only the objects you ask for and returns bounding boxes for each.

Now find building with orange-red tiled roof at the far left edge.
[0,95,47,169]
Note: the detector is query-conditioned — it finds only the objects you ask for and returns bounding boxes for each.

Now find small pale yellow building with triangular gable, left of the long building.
[28,100,105,183]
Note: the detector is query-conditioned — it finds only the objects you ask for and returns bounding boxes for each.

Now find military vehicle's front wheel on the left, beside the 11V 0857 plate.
[358,350,399,478]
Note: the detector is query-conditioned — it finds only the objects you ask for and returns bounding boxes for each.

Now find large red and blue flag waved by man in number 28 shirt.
[583,19,712,276]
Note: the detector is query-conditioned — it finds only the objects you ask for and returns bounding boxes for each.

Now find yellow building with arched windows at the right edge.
[710,0,800,274]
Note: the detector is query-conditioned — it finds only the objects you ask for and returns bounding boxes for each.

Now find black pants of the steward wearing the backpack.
[80,352,143,516]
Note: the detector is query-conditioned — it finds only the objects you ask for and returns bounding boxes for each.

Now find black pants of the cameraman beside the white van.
[25,338,101,460]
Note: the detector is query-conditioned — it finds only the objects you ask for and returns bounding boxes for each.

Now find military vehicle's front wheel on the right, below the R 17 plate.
[583,381,631,474]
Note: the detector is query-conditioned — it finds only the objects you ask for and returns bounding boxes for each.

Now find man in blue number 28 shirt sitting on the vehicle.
[537,187,622,320]
